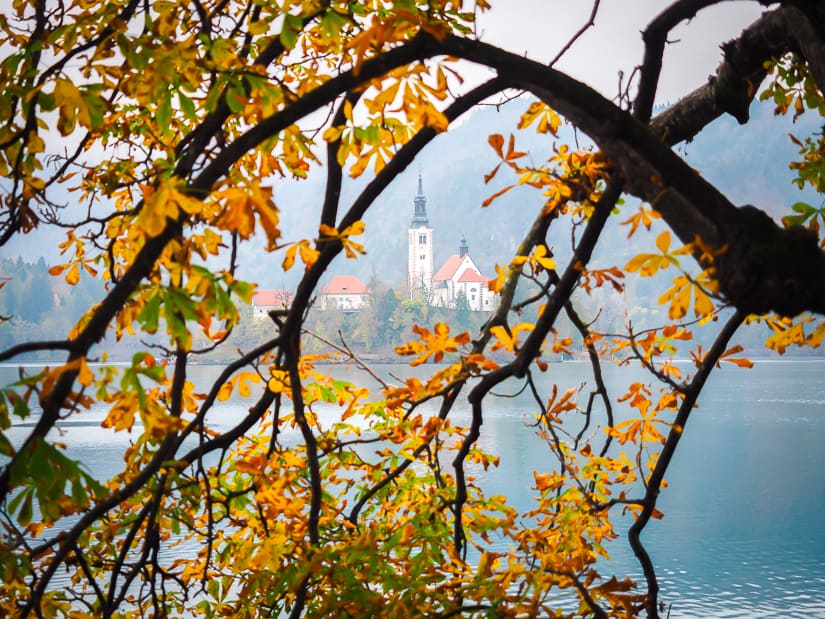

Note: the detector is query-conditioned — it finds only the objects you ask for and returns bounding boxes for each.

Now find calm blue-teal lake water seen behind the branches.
[0,360,825,619]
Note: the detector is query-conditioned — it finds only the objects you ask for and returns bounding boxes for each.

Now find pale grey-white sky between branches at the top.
[479,0,765,103]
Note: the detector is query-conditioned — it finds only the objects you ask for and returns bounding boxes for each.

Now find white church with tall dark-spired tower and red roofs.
[407,174,498,312]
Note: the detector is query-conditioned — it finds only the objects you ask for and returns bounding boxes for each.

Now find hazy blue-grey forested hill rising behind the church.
[233,94,819,294]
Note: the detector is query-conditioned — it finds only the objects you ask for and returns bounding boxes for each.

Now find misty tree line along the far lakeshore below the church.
[0,256,822,363]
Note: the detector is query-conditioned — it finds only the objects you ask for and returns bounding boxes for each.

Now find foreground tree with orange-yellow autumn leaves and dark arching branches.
[0,0,825,617]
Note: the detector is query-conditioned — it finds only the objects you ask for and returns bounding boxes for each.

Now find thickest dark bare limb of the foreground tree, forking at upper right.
[428,7,825,316]
